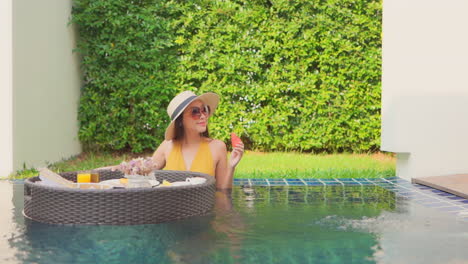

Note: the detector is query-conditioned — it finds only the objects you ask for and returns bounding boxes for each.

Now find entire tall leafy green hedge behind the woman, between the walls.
[73,0,382,152]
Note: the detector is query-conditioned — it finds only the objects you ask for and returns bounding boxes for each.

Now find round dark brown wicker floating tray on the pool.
[24,170,215,225]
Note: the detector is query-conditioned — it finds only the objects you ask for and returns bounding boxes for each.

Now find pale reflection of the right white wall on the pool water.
[316,199,468,264]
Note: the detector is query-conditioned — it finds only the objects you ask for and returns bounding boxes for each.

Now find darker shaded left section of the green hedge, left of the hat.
[73,0,177,152]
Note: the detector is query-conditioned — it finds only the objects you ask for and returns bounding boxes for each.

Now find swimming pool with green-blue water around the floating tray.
[0,178,468,263]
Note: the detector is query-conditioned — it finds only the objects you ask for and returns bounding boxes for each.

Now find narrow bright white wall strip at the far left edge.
[0,0,13,177]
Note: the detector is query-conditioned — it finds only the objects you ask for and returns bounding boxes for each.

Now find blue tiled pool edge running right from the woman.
[234,177,468,222]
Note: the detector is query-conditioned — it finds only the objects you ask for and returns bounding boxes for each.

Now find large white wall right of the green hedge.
[381,0,468,179]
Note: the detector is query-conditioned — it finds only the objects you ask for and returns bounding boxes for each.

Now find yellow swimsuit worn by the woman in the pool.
[164,140,215,176]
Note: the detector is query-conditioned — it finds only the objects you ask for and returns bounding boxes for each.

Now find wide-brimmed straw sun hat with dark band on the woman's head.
[164,91,219,140]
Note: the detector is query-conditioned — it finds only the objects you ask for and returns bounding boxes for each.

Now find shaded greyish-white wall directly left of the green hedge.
[0,0,81,176]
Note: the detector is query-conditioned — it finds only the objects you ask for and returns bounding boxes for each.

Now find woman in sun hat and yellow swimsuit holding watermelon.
[153,91,244,189]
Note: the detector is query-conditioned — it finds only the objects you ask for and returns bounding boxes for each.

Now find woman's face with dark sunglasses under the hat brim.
[183,100,210,134]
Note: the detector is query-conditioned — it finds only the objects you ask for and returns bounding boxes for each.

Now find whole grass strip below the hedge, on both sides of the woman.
[11,151,396,179]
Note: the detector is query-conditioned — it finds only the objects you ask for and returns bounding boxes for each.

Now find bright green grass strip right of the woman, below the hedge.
[236,152,396,179]
